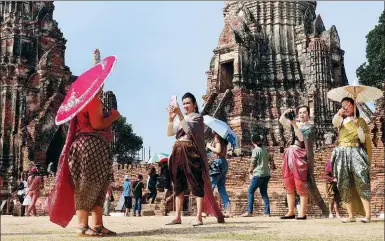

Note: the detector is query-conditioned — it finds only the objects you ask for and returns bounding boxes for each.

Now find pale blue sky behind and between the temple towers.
[54,1,384,157]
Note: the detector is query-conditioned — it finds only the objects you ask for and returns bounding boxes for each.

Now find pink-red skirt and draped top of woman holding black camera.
[279,115,315,196]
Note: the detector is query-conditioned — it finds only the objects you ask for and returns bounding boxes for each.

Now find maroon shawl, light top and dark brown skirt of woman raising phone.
[167,113,224,222]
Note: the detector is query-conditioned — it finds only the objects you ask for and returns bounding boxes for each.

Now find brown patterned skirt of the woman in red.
[69,133,112,211]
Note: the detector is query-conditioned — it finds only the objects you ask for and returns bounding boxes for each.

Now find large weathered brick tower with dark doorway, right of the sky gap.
[203,1,356,153]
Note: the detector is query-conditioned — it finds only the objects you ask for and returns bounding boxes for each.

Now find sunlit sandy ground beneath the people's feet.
[0,216,384,241]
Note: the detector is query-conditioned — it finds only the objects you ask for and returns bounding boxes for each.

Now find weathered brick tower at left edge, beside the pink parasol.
[0,1,74,194]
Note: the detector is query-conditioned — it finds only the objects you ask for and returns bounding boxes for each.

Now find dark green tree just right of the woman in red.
[112,116,143,163]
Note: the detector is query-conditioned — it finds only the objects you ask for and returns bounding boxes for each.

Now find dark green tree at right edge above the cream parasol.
[356,11,385,88]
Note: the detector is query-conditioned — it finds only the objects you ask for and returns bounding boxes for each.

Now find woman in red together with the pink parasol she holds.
[47,56,120,236]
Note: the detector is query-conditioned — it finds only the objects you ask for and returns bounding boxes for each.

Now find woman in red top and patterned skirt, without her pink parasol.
[48,88,120,236]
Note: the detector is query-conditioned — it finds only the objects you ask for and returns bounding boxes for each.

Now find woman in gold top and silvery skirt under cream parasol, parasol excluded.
[332,97,372,223]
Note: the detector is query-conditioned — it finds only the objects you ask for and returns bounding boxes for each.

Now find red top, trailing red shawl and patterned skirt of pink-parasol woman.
[47,100,112,227]
